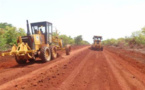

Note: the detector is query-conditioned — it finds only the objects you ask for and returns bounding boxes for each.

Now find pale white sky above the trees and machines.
[0,0,145,43]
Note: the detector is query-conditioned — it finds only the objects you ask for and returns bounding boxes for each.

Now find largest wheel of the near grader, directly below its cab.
[40,47,51,62]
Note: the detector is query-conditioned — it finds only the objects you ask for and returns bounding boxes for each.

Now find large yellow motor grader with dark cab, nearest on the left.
[2,20,71,64]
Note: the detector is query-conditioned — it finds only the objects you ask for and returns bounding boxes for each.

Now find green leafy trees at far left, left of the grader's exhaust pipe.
[0,23,26,50]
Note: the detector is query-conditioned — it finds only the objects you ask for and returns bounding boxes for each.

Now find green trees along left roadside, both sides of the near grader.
[0,23,89,51]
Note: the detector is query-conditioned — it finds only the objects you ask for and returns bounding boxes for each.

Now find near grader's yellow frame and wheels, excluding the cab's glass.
[2,21,71,64]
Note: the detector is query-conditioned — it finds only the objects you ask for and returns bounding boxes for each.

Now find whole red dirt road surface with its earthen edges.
[0,46,145,90]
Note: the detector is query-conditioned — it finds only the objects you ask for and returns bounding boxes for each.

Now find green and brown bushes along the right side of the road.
[103,27,145,48]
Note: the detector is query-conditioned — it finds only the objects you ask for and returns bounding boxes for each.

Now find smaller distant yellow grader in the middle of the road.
[91,36,103,51]
